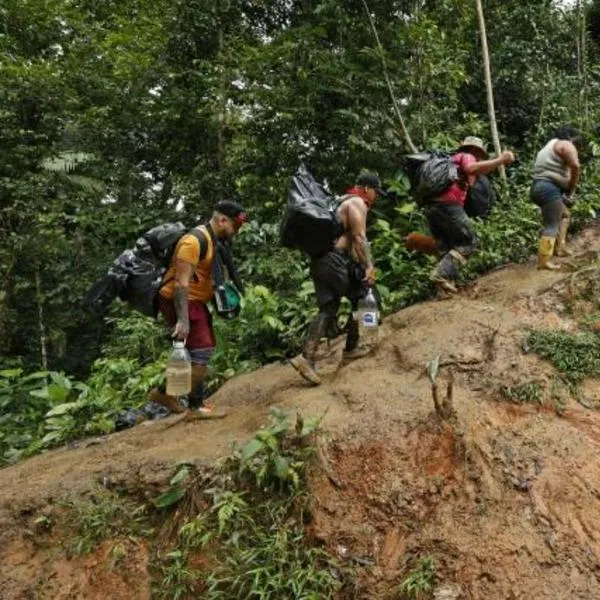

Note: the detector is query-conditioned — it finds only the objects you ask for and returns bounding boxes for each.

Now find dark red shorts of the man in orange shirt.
[158,296,216,365]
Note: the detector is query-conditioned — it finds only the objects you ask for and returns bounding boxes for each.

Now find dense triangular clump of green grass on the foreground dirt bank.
[155,411,341,600]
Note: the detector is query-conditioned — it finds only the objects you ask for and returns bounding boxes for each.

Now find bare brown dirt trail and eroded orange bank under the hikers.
[0,228,600,600]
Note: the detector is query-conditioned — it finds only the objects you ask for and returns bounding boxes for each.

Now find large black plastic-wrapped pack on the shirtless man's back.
[280,165,344,257]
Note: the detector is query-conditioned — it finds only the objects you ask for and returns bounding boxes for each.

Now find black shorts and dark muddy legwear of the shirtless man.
[304,250,365,360]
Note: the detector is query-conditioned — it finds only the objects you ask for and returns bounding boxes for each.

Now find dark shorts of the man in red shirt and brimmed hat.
[425,202,477,257]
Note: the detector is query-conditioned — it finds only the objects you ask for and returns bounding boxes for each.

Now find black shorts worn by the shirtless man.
[310,250,364,307]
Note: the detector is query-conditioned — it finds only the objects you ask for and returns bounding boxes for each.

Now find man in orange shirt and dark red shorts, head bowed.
[149,200,248,418]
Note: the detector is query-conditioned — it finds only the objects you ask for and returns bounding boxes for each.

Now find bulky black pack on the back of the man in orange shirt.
[82,222,216,317]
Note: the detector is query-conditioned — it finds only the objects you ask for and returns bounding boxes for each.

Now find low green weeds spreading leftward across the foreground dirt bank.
[29,411,347,600]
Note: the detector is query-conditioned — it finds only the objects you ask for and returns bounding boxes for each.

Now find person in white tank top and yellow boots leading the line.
[530,125,581,270]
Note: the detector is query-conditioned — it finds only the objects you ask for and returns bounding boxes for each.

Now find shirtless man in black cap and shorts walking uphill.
[290,173,382,385]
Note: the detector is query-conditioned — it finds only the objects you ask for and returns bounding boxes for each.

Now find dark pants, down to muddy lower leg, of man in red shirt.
[425,203,477,279]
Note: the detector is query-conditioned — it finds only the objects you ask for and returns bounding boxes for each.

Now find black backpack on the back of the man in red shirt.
[404,150,461,205]
